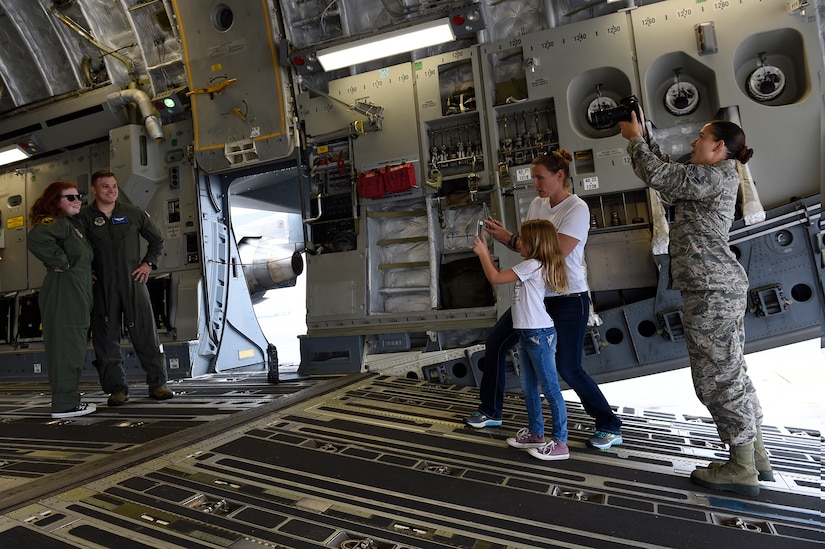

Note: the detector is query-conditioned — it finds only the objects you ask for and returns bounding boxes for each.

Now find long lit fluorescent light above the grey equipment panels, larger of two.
[318,17,455,71]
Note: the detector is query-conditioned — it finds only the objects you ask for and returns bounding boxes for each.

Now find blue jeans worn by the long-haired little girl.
[518,328,567,442]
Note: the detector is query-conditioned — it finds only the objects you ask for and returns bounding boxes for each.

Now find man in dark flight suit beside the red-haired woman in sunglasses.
[79,170,174,406]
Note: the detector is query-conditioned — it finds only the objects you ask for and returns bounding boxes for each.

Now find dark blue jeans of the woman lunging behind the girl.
[478,293,622,434]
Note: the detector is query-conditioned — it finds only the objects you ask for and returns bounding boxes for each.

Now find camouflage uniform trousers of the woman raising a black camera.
[682,290,762,446]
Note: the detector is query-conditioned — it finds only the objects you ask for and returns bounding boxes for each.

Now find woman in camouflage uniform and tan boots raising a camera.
[620,113,773,496]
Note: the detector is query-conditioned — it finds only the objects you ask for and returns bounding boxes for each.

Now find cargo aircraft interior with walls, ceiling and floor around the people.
[0,0,825,549]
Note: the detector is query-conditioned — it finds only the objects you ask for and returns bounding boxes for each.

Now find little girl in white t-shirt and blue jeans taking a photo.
[473,219,570,460]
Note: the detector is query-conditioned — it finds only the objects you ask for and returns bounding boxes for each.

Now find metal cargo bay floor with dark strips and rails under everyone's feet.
[0,374,825,549]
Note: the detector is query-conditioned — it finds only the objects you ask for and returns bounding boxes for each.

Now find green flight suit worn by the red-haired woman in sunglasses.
[27,217,93,412]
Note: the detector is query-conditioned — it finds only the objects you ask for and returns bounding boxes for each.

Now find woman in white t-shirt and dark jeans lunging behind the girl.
[465,149,622,450]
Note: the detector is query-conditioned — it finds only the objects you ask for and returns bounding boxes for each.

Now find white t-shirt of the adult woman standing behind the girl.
[527,194,590,296]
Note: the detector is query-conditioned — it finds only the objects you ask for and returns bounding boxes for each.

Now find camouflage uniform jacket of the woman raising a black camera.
[627,137,748,293]
